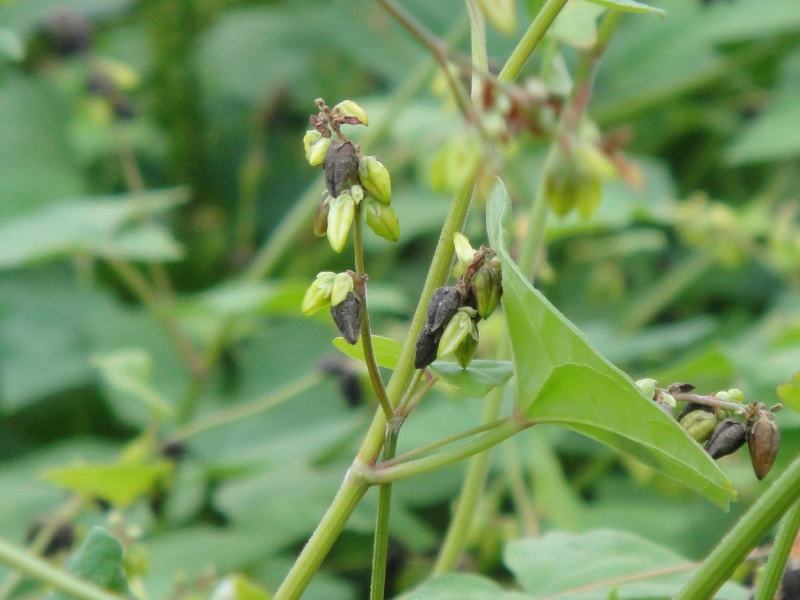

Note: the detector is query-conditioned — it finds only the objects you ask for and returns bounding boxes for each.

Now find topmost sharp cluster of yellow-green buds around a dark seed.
[303,98,400,252]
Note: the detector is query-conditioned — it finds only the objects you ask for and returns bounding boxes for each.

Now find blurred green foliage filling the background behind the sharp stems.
[0,0,800,599]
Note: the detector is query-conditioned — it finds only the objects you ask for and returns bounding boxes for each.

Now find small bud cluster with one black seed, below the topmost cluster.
[300,271,366,344]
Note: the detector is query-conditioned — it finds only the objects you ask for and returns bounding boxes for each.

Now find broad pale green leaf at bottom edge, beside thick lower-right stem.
[504,529,747,600]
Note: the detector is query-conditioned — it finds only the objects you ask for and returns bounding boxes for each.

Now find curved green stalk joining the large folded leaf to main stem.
[362,419,533,485]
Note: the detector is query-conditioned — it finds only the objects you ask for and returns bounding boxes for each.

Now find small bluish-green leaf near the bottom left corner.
[48,527,129,600]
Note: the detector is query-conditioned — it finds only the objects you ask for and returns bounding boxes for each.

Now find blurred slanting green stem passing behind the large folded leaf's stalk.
[433,387,503,576]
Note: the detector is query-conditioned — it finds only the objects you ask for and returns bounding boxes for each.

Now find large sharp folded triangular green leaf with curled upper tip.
[487,183,735,507]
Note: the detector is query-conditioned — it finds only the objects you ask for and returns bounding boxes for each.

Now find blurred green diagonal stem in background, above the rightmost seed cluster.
[622,252,714,331]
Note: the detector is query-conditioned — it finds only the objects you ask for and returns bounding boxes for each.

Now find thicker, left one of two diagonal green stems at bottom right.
[675,458,800,600]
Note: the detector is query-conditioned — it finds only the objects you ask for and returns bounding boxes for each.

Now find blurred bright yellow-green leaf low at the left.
[42,461,172,508]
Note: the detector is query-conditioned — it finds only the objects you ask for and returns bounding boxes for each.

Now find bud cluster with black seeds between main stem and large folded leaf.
[414,233,503,369]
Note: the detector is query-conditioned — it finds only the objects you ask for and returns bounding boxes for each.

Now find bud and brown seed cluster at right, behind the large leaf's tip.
[636,379,780,479]
